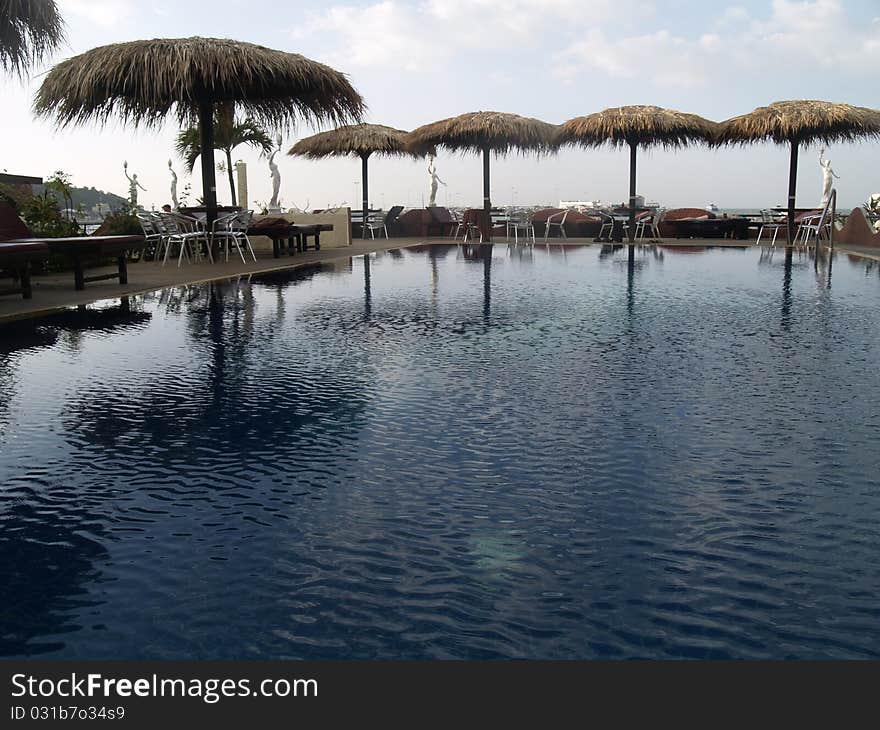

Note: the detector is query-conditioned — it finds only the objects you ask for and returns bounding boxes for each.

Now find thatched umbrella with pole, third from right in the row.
[409,112,556,240]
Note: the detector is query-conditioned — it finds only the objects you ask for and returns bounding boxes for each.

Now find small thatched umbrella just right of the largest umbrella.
[287,124,416,238]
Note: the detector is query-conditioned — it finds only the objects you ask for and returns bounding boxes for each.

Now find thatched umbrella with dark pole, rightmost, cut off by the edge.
[718,99,880,243]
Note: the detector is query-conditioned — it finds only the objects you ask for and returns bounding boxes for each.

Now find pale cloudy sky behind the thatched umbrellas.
[0,0,880,209]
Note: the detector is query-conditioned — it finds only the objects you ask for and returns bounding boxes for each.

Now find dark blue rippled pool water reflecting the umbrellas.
[0,245,880,658]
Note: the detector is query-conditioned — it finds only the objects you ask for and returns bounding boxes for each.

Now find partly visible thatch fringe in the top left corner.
[0,0,64,76]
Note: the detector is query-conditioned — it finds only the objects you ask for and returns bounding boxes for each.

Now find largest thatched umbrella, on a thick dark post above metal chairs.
[34,38,364,236]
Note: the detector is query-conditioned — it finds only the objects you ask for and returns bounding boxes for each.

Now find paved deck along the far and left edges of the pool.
[0,237,880,323]
